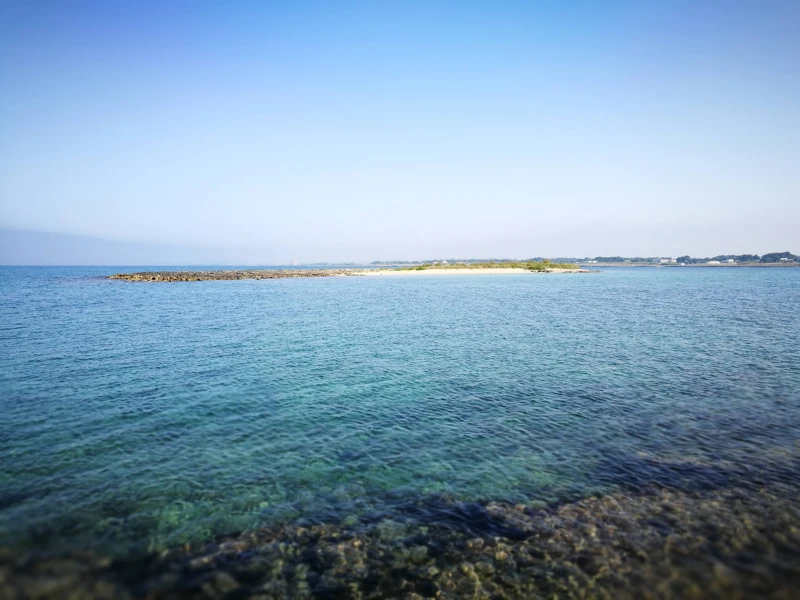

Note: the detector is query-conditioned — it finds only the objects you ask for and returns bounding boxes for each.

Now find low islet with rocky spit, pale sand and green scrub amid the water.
[108,260,591,282]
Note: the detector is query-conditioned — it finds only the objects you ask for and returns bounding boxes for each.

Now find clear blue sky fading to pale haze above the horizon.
[0,0,800,264]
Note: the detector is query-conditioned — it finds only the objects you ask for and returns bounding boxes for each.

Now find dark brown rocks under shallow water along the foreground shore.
[0,488,800,600]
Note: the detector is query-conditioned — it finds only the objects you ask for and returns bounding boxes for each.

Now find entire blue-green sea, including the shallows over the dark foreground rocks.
[0,267,800,597]
